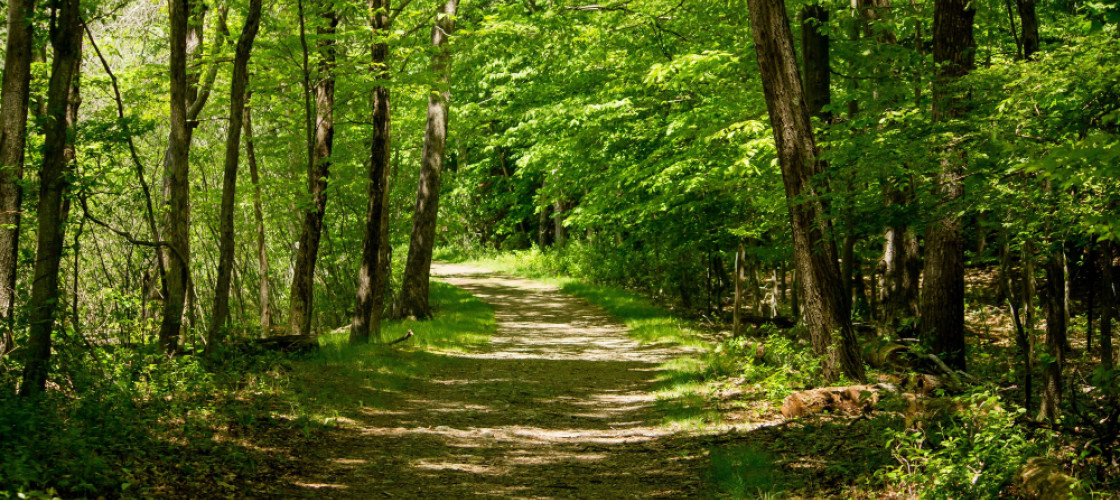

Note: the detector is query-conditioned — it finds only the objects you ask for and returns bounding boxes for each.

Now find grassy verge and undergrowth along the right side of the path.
[450,248,1111,499]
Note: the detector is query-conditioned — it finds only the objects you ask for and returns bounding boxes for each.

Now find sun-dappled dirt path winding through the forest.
[290,265,706,499]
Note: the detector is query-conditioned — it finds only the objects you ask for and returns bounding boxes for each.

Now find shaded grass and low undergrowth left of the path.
[0,283,495,498]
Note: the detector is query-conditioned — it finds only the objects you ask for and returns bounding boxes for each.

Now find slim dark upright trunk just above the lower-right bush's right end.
[1038,252,1067,423]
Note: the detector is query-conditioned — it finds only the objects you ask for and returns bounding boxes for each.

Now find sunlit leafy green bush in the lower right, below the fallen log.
[876,390,1044,499]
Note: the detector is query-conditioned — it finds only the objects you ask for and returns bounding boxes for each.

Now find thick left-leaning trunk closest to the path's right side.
[748,0,866,380]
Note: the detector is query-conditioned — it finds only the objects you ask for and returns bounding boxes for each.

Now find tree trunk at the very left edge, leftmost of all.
[0,0,35,355]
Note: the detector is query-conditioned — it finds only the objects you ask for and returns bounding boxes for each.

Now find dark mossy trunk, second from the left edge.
[19,0,82,396]
